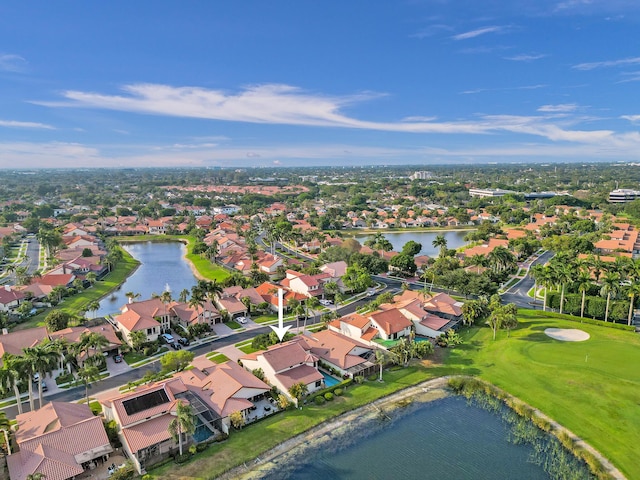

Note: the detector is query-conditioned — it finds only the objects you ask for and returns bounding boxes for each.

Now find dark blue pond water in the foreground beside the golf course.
[262,397,550,480]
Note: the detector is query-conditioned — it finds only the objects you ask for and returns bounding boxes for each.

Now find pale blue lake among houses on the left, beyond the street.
[95,242,197,316]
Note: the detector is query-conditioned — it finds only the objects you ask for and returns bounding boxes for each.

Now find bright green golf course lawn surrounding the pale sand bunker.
[446,310,640,478]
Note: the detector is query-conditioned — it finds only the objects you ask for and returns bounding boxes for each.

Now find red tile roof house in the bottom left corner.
[7,402,113,480]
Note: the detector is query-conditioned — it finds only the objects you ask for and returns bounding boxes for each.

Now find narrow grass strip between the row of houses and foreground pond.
[149,367,442,480]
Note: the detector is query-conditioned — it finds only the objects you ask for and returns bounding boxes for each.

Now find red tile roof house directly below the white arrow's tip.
[240,341,324,402]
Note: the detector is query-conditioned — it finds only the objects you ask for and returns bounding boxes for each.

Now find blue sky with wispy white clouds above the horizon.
[0,0,640,168]
